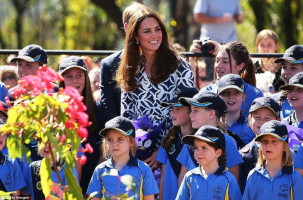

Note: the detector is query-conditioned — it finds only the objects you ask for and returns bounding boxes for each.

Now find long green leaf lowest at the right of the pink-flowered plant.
[64,168,83,200]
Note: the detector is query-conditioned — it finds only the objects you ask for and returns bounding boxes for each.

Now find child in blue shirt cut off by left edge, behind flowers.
[0,119,26,198]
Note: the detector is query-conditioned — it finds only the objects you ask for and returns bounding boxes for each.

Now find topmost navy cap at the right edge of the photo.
[275,45,303,63]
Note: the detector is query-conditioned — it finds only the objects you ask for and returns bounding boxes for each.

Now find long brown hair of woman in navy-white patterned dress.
[115,8,179,92]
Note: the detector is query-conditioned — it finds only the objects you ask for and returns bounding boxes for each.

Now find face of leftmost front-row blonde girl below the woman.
[105,130,132,159]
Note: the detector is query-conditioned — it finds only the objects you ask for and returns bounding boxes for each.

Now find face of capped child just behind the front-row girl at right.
[249,108,277,135]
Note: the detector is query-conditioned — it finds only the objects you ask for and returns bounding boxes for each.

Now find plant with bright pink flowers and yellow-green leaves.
[0,66,89,199]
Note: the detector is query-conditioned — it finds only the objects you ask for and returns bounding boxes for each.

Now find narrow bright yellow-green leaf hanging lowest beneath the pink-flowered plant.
[40,158,53,197]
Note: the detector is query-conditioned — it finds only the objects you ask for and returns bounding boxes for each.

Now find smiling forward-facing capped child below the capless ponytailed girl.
[218,74,255,144]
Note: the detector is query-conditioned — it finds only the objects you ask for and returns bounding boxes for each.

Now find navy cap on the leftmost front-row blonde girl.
[99,116,136,137]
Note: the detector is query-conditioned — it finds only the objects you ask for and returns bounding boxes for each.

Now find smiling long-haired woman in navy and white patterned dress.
[116,8,193,184]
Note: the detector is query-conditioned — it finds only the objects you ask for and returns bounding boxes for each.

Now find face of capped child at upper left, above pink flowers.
[17,60,40,79]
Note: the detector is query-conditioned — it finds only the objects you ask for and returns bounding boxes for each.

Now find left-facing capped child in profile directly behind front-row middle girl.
[177,91,243,184]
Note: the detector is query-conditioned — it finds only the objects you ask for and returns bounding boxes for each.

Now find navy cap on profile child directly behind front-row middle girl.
[179,91,227,118]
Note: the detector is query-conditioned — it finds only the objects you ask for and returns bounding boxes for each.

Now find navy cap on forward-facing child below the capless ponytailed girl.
[218,74,244,94]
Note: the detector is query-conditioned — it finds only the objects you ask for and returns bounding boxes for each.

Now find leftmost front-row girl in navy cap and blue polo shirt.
[87,116,159,200]
